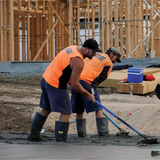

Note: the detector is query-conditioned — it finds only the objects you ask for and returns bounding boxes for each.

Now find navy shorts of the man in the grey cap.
[71,80,102,113]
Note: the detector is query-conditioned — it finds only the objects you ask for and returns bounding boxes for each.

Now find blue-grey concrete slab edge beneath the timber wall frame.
[0,58,160,73]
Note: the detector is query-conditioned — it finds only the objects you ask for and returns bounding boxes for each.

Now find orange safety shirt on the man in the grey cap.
[80,53,113,84]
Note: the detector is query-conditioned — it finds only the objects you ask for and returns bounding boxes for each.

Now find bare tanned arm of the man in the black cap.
[70,57,94,102]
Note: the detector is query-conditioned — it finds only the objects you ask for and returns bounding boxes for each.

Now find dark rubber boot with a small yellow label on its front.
[55,121,69,142]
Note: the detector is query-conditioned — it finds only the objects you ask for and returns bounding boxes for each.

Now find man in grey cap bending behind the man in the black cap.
[71,47,121,137]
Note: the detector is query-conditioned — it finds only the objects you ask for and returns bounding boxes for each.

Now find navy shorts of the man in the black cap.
[39,78,72,114]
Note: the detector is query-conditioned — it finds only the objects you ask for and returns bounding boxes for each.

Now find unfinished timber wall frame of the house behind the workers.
[0,0,160,61]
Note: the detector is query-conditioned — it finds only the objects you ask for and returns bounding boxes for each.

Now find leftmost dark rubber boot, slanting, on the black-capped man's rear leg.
[27,112,47,142]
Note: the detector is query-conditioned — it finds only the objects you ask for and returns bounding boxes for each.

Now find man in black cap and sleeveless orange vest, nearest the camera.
[27,38,101,142]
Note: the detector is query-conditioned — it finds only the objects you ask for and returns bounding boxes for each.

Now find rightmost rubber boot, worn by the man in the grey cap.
[96,117,109,136]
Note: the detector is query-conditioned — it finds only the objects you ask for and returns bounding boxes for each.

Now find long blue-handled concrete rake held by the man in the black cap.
[95,100,158,144]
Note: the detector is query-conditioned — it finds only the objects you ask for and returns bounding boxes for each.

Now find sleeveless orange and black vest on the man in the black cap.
[42,46,83,89]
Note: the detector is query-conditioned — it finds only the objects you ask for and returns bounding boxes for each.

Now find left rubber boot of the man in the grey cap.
[76,119,86,137]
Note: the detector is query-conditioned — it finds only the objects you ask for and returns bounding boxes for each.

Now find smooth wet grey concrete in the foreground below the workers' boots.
[0,143,160,160]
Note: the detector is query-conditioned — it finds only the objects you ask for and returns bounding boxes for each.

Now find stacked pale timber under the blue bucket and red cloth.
[99,68,160,94]
